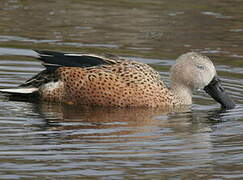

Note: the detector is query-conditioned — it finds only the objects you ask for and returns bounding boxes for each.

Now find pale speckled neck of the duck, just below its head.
[171,83,192,105]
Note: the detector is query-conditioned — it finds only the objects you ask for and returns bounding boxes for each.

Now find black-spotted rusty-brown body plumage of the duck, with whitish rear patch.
[41,56,173,107]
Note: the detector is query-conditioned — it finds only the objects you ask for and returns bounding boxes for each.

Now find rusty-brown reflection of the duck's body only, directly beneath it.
[35,103,190,139]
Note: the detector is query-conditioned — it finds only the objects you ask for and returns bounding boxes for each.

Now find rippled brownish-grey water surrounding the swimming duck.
[0,0,243,179]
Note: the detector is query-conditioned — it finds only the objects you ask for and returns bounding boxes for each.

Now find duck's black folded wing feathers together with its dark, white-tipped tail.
[0,50,119,94]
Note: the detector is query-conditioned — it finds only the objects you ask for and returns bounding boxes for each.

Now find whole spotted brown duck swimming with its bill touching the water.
[0,51,235,109]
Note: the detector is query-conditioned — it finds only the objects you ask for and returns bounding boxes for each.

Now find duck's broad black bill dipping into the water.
[204,76,235,109]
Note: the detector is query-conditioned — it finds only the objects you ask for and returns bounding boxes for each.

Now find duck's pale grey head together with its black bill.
[170,52,235,109]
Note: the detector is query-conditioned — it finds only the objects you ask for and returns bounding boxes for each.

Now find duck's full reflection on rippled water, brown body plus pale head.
[33,103,219,167]
